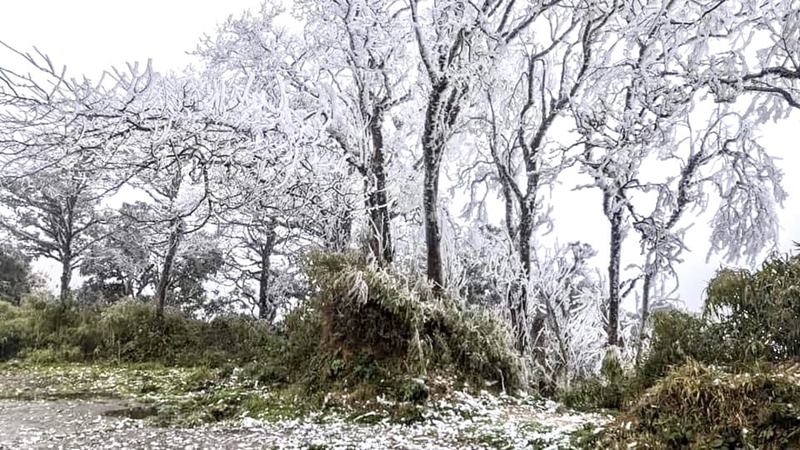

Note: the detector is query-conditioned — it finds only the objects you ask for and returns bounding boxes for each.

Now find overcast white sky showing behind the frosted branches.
[0,0,800,309]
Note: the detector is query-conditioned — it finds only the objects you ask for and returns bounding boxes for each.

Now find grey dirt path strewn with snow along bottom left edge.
[0,400,456,450]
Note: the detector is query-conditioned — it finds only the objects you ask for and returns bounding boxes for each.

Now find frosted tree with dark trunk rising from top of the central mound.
[300,0,411,265]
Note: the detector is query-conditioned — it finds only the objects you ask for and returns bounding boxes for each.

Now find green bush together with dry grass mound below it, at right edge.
[590,256,800,448]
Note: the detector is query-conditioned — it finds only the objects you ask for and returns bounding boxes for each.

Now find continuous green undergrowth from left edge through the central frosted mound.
[0,254,521,401]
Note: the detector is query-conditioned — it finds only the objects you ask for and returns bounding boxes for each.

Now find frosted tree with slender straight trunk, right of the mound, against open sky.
[572,1,713,345]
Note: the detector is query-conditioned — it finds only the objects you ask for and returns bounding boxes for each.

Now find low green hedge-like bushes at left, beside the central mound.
[0,297,276,365]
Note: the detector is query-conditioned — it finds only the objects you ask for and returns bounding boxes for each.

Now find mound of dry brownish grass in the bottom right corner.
[601,361,800,449]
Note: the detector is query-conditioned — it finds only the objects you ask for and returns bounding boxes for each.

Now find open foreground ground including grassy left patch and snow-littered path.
[0,367,607,450]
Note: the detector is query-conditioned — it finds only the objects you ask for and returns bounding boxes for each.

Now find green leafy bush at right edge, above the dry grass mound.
[636,256,800,388]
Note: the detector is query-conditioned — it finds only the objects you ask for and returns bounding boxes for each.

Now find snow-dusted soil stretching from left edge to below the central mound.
[0,371,609,450]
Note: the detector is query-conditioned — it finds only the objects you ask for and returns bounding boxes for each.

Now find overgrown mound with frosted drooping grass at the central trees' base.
[304,254,521,389]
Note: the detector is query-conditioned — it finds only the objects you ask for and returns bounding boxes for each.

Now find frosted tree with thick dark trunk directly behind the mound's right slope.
[409,0,559,295]
